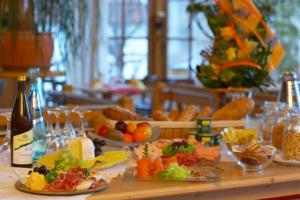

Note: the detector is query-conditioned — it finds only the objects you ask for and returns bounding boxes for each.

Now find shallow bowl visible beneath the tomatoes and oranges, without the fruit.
[88,127,160,147]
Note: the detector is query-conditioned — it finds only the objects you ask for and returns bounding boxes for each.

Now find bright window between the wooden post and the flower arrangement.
[167,0,210,79]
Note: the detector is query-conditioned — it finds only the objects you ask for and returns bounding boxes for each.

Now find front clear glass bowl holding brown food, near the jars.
[231,143,276,172]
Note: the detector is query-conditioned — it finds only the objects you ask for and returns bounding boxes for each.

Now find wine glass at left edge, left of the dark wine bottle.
[0,112,11,161]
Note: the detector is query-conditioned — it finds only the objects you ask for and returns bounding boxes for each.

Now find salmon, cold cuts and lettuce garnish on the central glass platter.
[130,139,220,181]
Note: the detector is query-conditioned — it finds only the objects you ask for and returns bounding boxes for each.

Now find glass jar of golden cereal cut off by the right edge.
[282,114,300,161]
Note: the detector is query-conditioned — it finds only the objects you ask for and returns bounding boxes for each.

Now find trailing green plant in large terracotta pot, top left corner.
[0,0,85,70]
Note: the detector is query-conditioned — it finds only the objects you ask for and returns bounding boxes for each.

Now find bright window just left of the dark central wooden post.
[106,0,148,79]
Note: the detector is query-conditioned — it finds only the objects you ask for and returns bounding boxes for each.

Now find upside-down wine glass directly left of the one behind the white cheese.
[60,106,76,143]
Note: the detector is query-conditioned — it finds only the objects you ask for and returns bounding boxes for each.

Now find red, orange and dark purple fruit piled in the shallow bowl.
[97,121,153,143]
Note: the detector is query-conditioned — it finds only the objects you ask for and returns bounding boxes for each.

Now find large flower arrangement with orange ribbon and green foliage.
[188,0,284,88]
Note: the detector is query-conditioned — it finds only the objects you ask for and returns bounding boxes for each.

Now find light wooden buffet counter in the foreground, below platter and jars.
[87,162,300,200]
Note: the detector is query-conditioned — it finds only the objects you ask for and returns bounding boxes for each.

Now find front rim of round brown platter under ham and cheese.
[15,180,108,196]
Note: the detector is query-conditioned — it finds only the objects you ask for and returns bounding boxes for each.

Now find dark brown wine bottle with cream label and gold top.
[10,76,33,167]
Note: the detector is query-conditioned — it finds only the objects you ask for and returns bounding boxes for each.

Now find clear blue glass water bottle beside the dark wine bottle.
[29,68,47,161]
